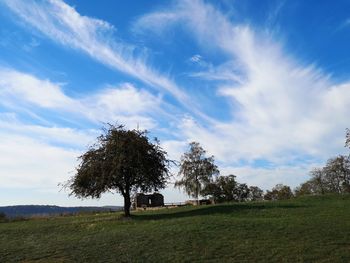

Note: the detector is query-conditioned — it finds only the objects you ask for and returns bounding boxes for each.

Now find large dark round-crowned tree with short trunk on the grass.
[67,124,170,216]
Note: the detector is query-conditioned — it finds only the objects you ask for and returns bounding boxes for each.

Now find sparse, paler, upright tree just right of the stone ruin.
[175,142,219,202]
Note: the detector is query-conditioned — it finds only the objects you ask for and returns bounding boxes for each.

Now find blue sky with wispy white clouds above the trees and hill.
[0,0,350,206]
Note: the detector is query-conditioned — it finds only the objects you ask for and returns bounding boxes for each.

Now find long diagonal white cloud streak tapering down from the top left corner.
[4,0,189,103]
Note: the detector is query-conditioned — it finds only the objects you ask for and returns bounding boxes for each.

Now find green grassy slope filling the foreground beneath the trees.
[0,195,350,262]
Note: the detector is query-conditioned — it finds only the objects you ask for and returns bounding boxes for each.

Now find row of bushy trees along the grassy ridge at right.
[197,129,350,203]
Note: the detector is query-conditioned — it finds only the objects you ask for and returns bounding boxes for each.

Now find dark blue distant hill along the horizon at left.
[0,205,123,220]
